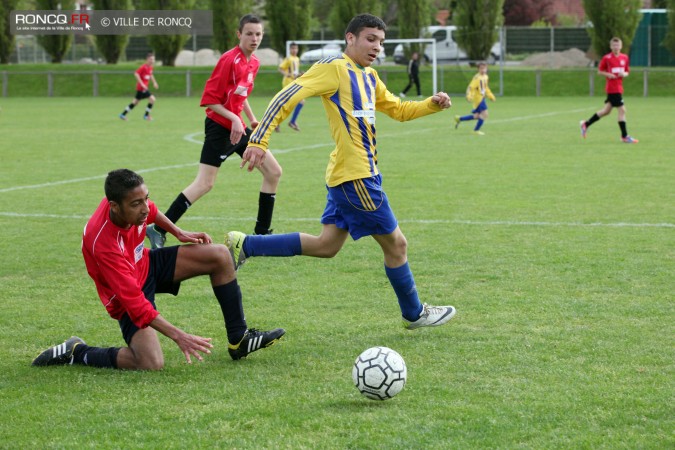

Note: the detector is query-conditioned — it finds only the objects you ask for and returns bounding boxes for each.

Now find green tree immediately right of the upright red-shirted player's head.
[265,0,312,55]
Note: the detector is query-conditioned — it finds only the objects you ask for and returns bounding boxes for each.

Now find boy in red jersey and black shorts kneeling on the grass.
[33,169,285,370]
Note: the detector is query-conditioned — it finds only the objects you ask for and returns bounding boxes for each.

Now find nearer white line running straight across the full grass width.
[0,211,675,228]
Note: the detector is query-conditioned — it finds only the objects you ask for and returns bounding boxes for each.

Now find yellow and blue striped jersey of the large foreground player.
[249,54,441,187]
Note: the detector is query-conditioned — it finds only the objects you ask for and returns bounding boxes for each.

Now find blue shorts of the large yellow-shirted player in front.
[321,175,398,240]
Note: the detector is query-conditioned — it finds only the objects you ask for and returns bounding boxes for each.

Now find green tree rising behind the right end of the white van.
[453,0,504,61]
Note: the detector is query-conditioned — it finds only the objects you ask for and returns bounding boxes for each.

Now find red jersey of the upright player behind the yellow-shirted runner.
[200,46,260,130]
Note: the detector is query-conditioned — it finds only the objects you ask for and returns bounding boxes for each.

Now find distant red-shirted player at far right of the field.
[580,37,639,144]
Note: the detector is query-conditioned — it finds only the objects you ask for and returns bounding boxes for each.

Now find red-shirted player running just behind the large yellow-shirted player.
[148,14,281,248]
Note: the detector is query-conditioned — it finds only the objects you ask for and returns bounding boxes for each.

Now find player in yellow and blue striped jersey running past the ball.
[226,14,455,329]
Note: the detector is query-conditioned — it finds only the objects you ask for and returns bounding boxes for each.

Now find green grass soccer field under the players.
[0,95,675,449]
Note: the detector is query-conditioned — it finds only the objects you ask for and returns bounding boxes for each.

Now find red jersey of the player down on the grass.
[82,198,159,328]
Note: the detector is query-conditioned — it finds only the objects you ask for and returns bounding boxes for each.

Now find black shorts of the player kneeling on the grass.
[119,245,180,345]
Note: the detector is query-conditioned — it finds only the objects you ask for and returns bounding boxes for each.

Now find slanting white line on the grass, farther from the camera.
[0,108,588,193]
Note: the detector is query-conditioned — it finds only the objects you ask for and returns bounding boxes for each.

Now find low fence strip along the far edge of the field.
[0,65,675,97]
